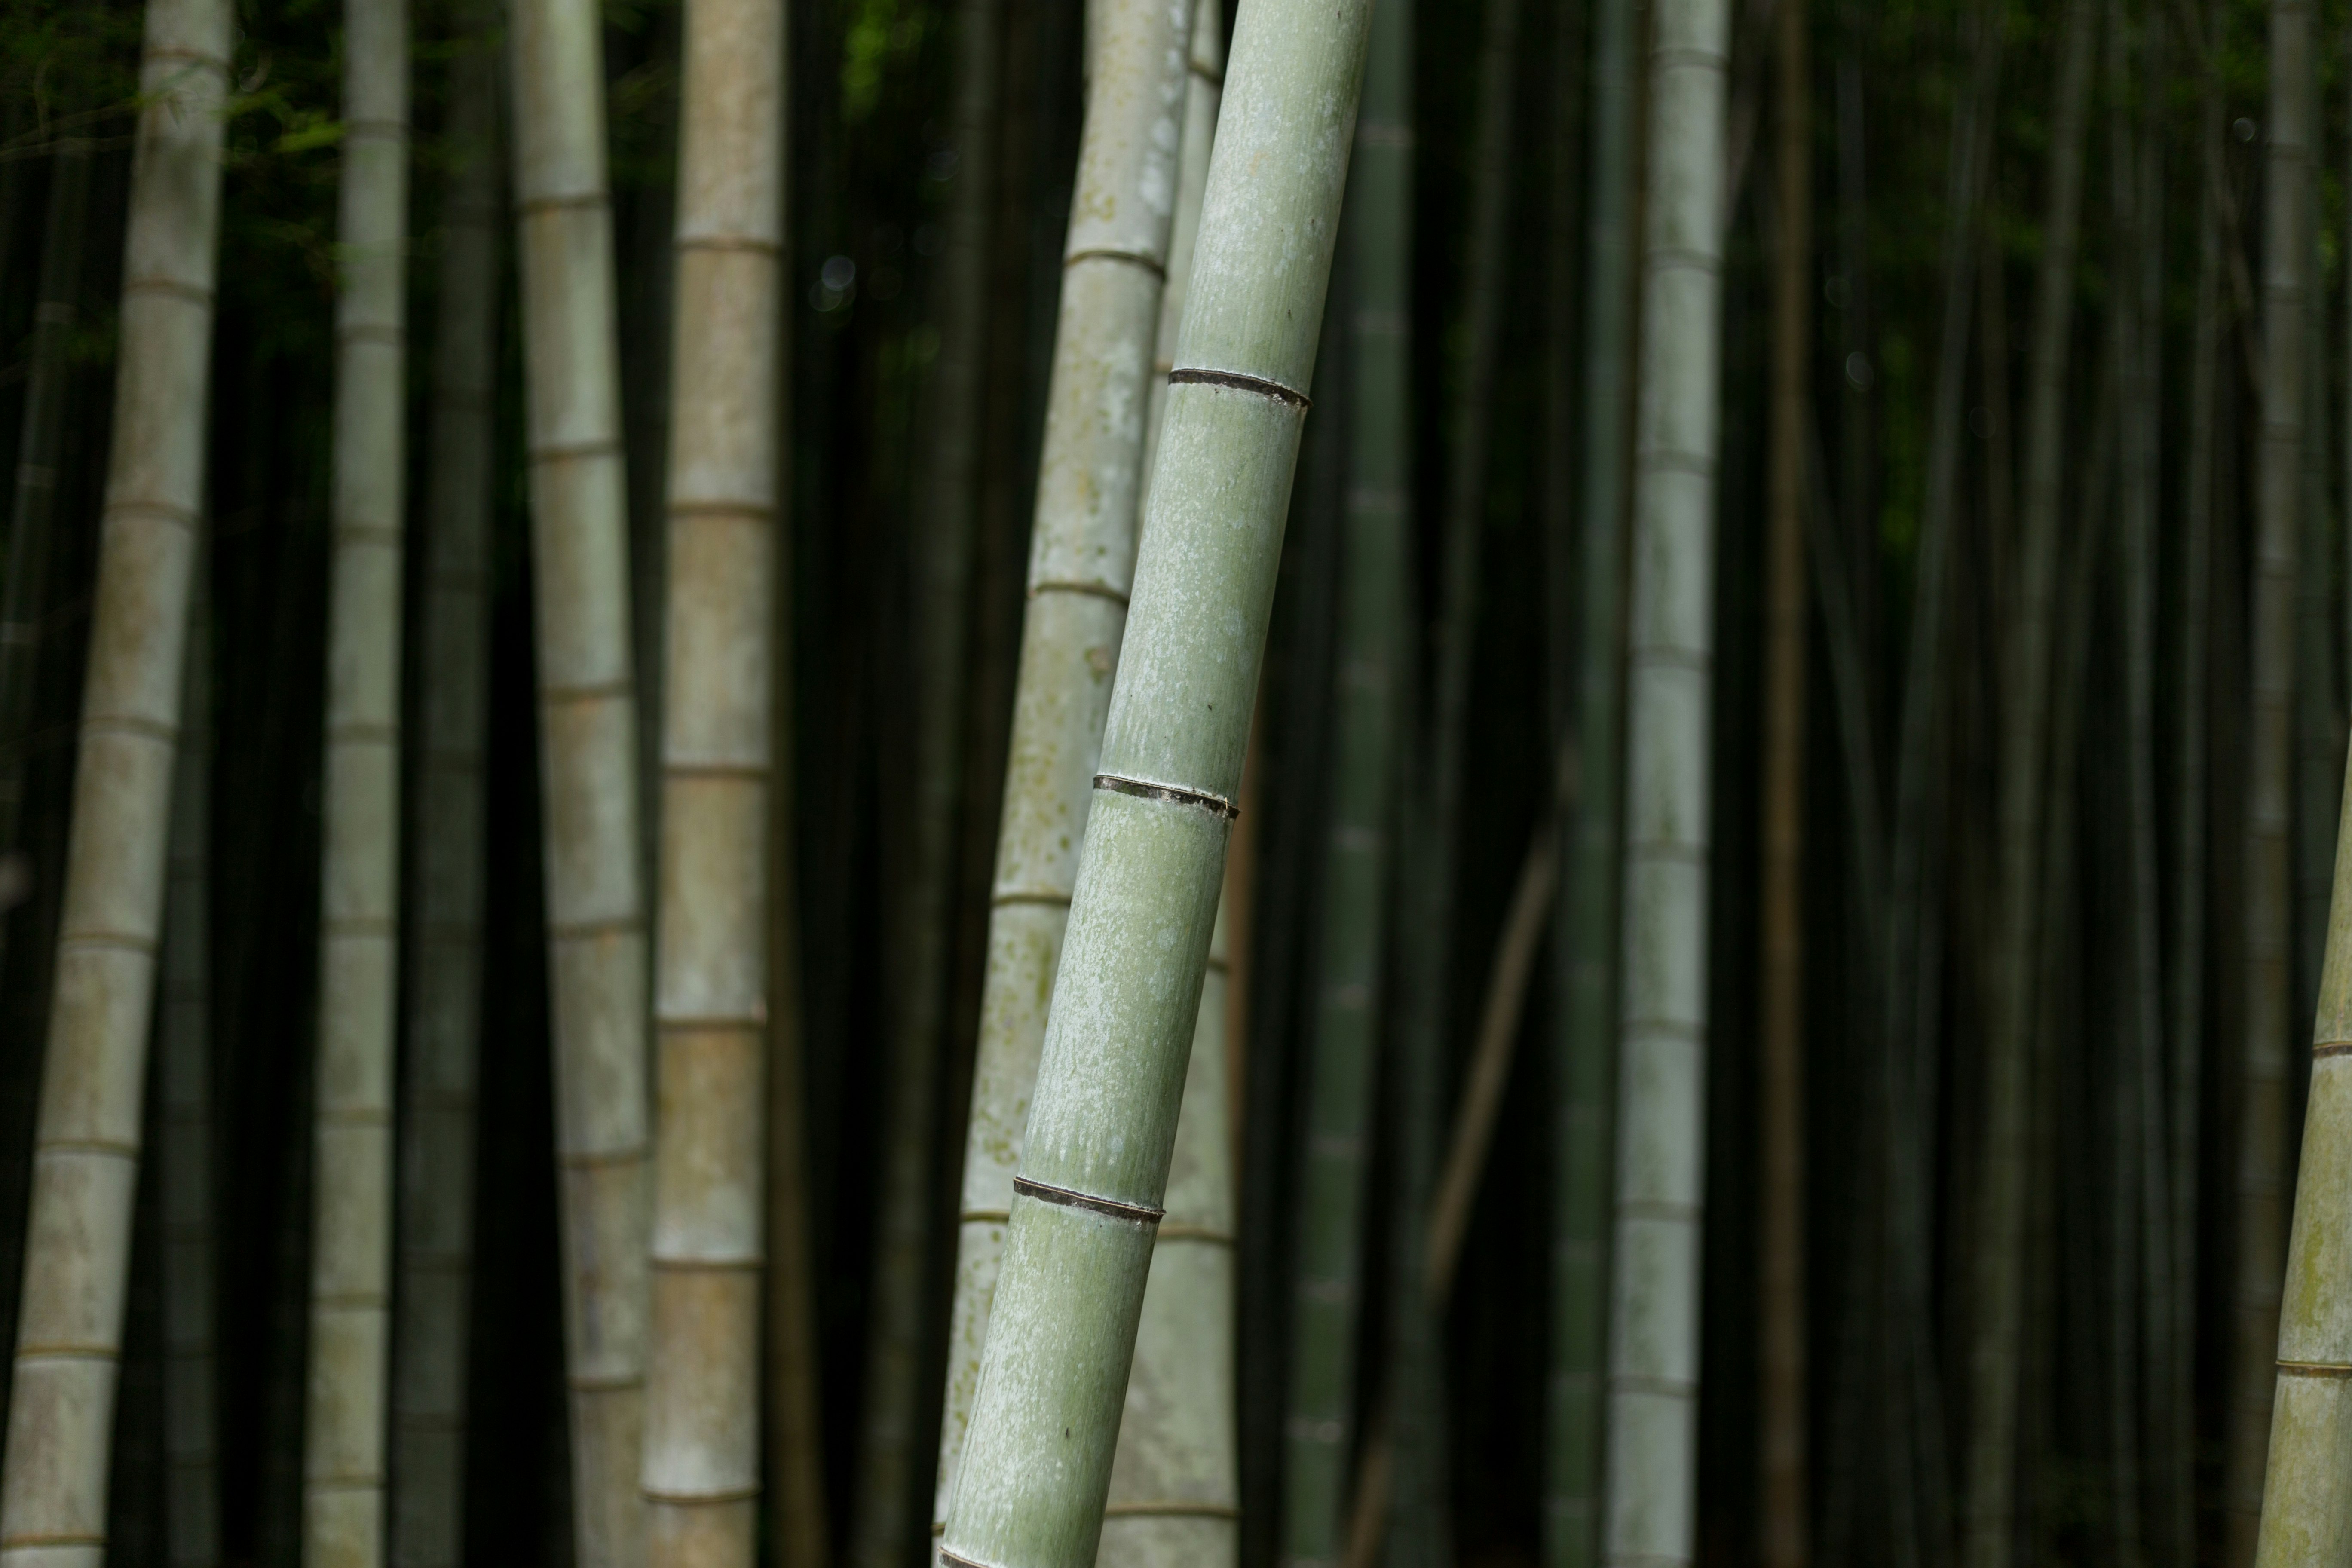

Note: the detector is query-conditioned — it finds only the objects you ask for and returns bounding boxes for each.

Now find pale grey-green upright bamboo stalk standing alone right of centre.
[1602,0,1731,1563]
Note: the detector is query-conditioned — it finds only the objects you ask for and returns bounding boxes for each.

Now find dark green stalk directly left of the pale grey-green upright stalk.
[1543,0,1639,1542]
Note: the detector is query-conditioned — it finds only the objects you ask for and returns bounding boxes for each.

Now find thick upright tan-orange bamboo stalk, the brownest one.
[644,0,783,1568]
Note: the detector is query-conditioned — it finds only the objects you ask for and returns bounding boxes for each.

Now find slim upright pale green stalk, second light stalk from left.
[303,0,409,1568]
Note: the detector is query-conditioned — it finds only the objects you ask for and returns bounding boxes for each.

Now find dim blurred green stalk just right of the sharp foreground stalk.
[1282,0,1414,1568]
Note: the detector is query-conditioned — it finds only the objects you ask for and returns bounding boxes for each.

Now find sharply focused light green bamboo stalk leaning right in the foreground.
[941,0,1371,1568]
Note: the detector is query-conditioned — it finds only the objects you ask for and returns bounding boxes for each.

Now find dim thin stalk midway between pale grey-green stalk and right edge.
[1964,12,2096,1568]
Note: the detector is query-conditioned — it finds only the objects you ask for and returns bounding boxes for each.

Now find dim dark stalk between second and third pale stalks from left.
[390,21,501,1568]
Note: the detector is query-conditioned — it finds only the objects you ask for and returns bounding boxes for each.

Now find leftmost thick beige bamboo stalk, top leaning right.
[0,0,230,1568]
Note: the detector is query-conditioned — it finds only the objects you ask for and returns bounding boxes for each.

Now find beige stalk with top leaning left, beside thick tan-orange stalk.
[508,0,649,1568]
